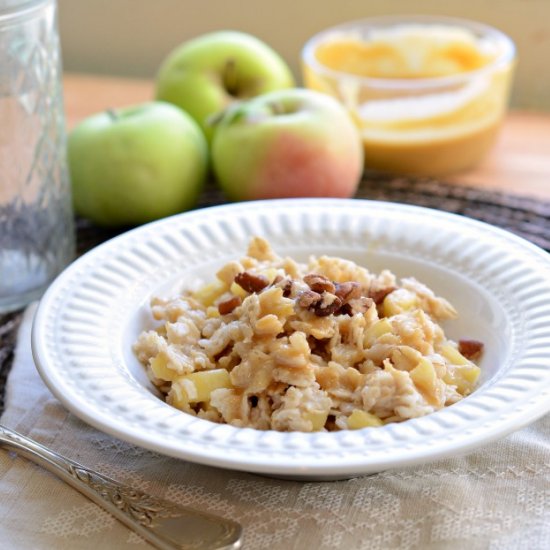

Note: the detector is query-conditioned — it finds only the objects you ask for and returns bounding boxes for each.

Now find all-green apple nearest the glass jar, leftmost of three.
[68,101,208,225]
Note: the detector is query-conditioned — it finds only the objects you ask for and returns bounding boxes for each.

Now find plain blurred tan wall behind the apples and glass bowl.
[58,0,550,111]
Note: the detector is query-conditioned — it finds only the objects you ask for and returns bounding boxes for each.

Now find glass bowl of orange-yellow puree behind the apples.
[302,16,516,176]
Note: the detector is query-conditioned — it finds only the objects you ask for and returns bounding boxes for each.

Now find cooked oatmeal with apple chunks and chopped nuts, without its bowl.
[134,237,483,432]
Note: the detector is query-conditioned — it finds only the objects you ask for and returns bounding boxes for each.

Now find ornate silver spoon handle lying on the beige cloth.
[0,425,242,550]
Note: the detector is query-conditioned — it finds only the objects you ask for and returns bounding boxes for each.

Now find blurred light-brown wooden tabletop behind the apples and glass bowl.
[64,74,550,200]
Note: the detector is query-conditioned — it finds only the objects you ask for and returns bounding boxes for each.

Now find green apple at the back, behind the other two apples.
[156,31,294,140]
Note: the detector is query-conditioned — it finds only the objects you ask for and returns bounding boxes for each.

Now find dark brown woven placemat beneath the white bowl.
[0,176,550,414]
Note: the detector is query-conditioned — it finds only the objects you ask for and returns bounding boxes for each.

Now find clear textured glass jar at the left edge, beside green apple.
[0,0,74,313]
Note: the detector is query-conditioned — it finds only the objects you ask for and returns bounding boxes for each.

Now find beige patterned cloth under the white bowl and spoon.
[0,308,550,550]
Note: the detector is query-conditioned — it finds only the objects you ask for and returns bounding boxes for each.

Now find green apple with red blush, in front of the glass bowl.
[211,88,363,200]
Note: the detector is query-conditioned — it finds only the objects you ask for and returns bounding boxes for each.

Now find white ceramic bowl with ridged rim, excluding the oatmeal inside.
[32,199,550,479]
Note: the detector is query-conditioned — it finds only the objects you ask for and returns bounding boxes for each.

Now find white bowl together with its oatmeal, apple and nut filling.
[32,199,550,479]
